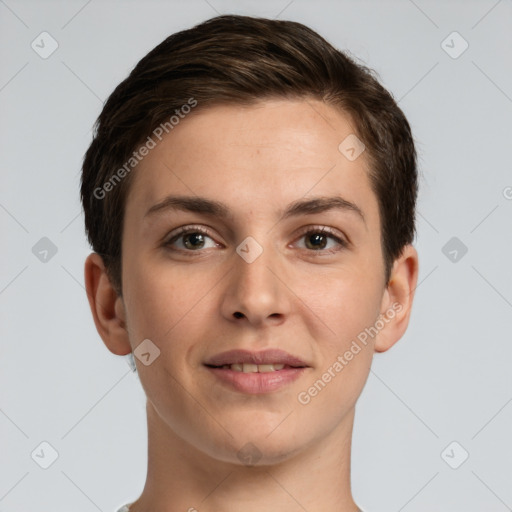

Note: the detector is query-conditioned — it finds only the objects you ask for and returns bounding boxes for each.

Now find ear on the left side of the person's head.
[84,252,132,356]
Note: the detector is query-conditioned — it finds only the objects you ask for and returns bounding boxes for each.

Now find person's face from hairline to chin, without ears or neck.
[122,100,385,464]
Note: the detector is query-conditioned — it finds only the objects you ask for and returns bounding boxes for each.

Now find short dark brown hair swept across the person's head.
[81,15,418,295]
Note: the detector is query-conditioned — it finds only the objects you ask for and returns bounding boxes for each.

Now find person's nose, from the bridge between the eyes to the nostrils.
[222,237,290,327]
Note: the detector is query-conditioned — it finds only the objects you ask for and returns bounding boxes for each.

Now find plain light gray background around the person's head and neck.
[0,0,512,512]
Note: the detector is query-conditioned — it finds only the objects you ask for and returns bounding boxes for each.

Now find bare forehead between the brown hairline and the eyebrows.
[126,100,378,228]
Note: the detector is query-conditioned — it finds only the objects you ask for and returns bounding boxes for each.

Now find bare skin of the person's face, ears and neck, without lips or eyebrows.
[85,100,418,512]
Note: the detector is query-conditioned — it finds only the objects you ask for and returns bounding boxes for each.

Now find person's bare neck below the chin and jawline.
[130,400,359,512]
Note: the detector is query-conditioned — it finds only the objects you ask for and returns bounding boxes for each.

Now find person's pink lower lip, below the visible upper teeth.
[206,366,308,395]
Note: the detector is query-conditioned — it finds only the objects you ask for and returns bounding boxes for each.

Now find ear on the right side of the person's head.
[375,244,419,352]
